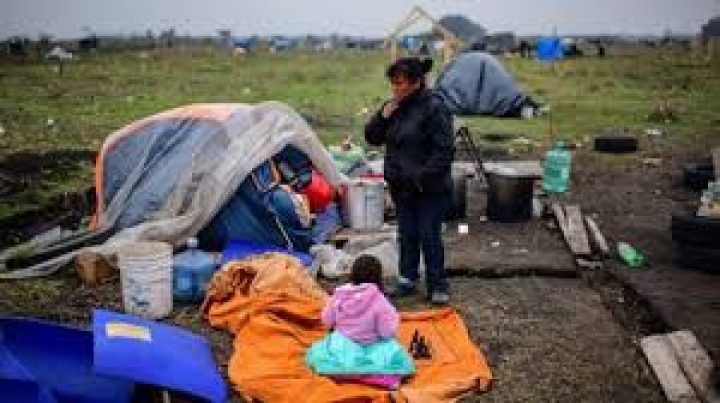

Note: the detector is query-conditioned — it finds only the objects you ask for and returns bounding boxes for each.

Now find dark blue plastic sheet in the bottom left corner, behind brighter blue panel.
[0,318,135,403]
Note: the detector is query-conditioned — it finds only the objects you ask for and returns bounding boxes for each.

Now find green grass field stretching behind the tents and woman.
[0,48,720,223]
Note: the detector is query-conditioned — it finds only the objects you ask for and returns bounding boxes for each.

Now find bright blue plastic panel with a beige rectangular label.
[93,310,227,402]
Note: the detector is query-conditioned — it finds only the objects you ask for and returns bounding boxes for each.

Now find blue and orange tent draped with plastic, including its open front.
[95,102,343,249]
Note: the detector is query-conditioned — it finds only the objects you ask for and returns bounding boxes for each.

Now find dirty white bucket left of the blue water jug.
[118,242,173,319]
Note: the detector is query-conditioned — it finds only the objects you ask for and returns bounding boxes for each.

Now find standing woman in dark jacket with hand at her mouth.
[365,57,454,304]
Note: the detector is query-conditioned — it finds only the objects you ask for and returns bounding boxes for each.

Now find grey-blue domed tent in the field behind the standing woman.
[435,52,528,116]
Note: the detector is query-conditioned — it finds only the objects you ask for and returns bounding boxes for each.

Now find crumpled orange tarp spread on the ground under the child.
[202,254,492,402]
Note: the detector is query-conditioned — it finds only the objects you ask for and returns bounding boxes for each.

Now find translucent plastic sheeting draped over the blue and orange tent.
[94,102,345,253]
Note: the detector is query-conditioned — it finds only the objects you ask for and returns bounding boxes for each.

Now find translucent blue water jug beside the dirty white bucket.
[173,238,217,302]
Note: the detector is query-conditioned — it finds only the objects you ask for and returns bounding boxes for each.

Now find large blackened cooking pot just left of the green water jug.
[487,172,535,223]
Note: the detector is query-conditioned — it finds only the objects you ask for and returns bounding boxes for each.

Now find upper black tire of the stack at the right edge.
[670,215,720,249]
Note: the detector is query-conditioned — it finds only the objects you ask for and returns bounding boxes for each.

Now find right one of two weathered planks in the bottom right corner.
[667,330,720,403]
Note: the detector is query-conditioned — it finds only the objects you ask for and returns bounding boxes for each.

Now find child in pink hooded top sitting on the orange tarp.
[306,255,415,389]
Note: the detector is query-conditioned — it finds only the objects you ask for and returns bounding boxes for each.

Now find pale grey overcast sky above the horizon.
[0,0,720,38]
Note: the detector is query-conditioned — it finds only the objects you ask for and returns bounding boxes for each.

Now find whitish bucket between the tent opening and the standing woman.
[343,179,385,229]
